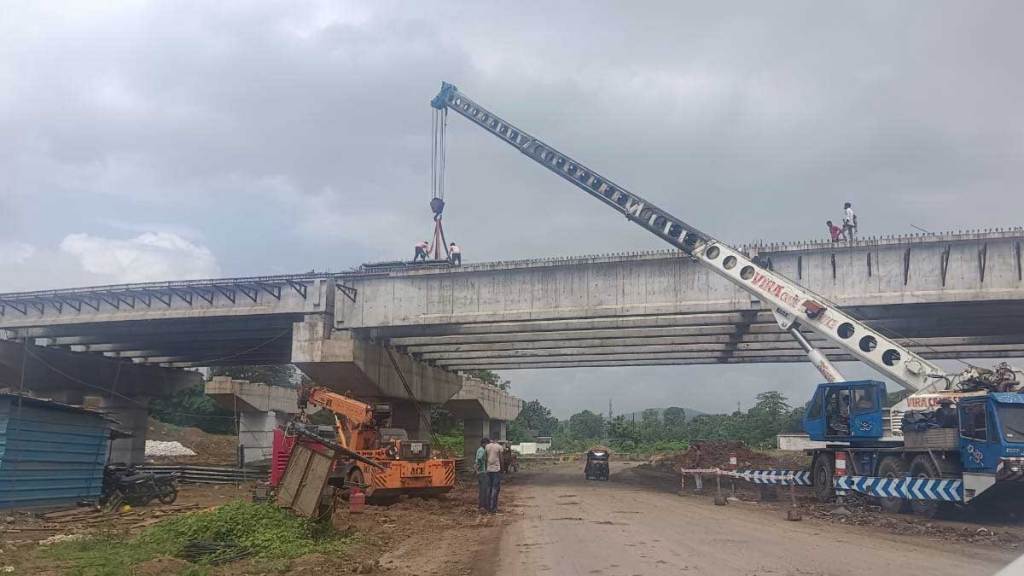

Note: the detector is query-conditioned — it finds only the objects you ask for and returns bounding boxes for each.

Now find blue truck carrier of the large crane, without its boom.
[803,380,1024,517]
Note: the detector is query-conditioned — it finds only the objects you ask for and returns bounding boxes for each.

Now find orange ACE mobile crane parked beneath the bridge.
[270,386,455,501]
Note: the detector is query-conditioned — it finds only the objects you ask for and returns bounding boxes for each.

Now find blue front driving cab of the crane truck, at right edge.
[957,393,1024,480]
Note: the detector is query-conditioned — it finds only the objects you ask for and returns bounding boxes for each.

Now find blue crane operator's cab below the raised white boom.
[804,380,886,442]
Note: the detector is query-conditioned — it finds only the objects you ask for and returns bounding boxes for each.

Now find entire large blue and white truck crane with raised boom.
[430,82,1024,516]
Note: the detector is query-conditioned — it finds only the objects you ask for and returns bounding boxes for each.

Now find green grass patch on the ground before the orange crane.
[40,500,351,576]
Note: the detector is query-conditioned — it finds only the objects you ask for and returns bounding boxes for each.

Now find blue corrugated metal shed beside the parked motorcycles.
[0,394,112,508]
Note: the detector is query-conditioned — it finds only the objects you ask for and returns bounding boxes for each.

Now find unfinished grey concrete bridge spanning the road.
[0,229,1024,457]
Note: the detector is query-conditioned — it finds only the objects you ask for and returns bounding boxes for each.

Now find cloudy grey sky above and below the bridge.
[0,0,1024,416]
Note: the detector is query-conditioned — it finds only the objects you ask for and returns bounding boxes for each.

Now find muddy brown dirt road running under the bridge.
[496,464,1016,576]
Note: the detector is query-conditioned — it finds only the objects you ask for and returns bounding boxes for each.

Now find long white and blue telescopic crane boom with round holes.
[430,82,945,392]
